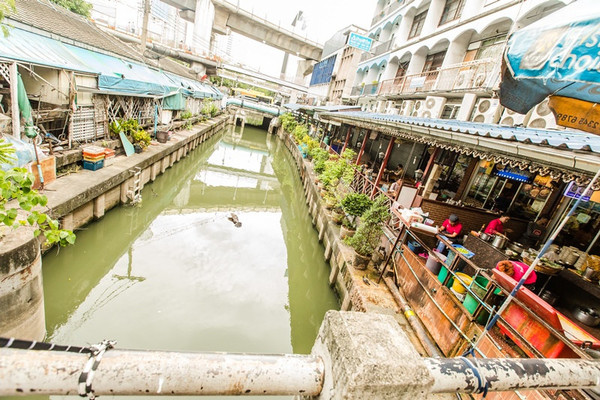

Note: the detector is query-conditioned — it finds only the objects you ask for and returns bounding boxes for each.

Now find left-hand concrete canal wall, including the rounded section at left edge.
[0,114,229,340]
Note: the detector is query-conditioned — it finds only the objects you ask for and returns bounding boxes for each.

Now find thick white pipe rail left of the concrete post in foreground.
[0,348,324,396]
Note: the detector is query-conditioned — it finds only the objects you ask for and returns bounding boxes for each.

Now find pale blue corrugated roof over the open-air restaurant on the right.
[332,111,600,153]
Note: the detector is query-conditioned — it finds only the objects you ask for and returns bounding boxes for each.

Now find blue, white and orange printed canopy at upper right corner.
[500,0,600,134]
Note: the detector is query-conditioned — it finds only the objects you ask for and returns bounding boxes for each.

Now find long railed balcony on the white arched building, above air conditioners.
[377,59,500,96]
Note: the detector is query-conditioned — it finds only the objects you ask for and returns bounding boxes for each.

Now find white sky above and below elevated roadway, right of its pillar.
[220,0,377,76]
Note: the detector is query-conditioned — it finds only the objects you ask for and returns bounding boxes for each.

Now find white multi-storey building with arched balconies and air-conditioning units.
[349,0,575,128]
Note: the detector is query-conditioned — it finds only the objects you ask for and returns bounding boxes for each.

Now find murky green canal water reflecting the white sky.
[18,127,339,399]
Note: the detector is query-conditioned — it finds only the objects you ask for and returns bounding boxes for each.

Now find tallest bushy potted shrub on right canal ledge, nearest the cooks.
[345,195,389,269]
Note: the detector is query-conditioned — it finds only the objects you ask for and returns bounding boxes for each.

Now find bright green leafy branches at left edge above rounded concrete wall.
[0,140,75,246]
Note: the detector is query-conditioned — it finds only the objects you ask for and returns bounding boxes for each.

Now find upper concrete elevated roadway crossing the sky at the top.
[162,0,323,61]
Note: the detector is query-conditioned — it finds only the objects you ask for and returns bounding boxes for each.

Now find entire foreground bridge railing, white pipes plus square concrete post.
[0,311,600,400]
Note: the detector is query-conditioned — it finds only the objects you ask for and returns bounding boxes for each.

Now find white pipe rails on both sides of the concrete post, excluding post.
[0,348,600,399]
